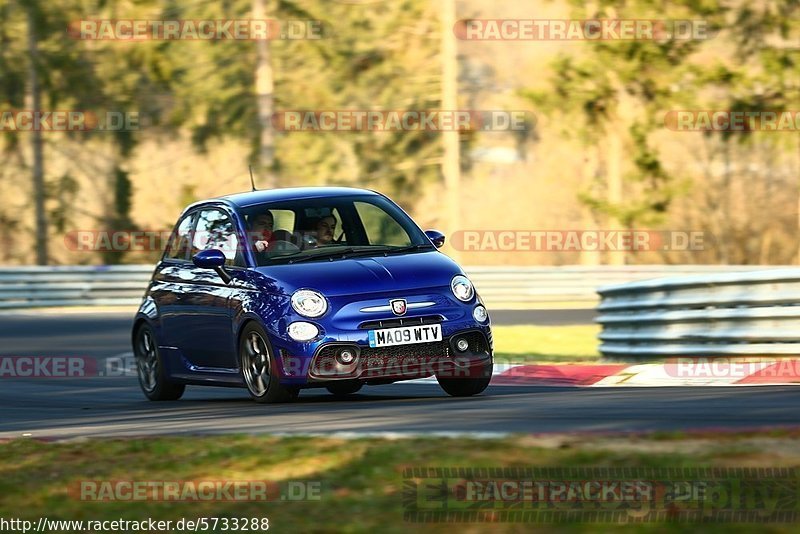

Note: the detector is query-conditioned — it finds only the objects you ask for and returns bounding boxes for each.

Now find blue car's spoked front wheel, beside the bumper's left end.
[239,323,299,404]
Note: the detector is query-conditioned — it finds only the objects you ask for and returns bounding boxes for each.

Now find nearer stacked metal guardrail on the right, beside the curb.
[597,268,800,358]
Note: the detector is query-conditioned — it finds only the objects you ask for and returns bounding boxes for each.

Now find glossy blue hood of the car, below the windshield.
[256,251,463,296]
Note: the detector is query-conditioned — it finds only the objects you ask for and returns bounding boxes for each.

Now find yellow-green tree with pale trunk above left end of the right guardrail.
[523,0,726,261]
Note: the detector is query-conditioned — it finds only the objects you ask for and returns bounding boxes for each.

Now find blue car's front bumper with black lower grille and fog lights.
[272,288,492,387]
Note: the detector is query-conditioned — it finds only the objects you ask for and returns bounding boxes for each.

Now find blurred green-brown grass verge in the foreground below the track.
[0,431,800,532]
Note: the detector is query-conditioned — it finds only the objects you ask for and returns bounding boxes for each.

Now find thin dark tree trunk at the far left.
[26,3,48,265]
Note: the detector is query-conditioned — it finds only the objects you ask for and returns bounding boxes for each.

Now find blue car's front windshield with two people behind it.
[242,195,432,266]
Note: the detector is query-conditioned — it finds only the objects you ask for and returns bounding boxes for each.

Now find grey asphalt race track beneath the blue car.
[0,312,800,438]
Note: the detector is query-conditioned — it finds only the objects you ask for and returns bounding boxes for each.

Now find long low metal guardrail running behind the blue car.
[0,265,780,310]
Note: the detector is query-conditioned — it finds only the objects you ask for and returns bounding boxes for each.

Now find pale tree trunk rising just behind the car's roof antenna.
[253,0,278,189]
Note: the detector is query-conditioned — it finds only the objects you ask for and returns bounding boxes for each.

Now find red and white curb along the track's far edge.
[412,358,800,387]
